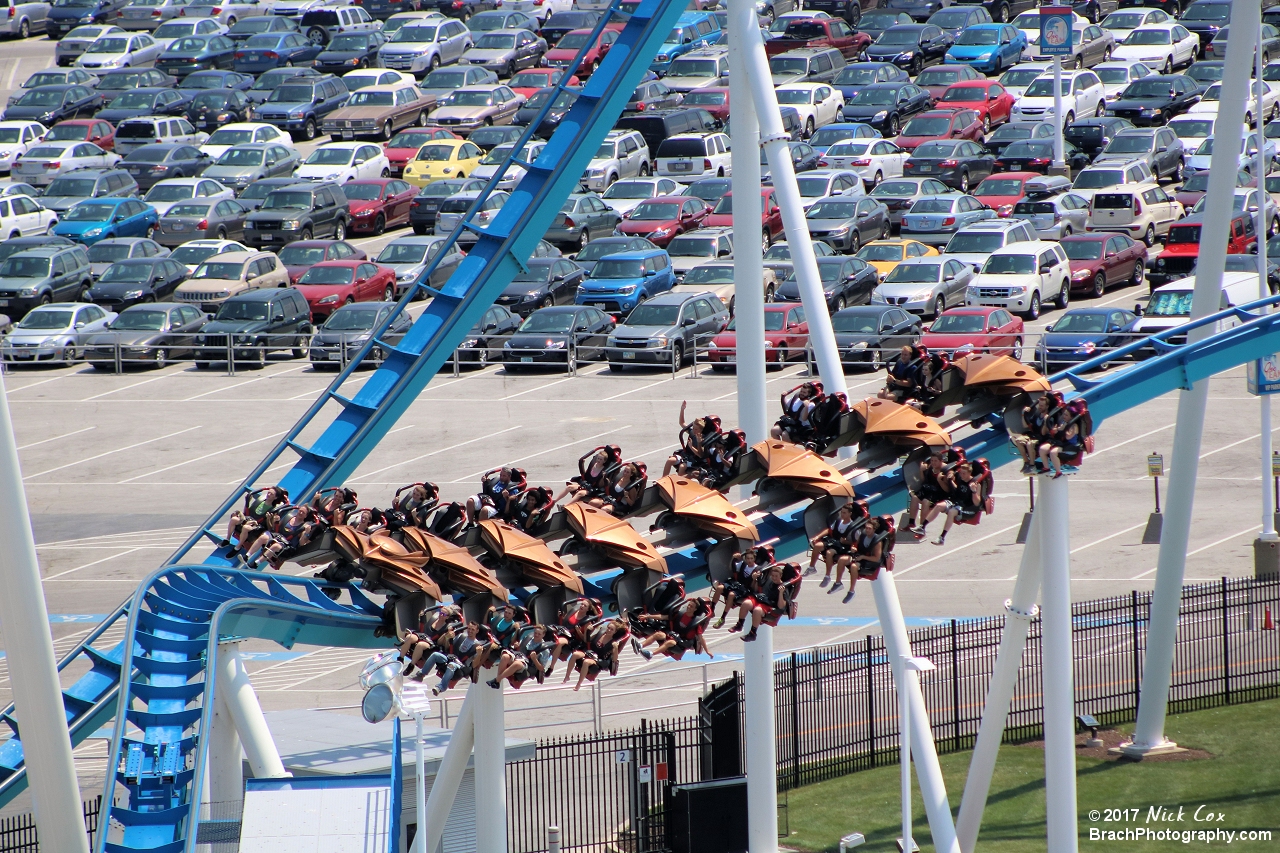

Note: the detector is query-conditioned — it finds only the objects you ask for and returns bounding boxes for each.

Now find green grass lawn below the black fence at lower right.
[781,701,1280,853]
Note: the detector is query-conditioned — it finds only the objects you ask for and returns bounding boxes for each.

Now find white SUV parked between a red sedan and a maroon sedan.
[964,240,1071,320]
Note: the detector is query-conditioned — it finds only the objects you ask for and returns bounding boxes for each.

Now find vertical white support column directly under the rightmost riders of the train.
[1036,476,1079,853]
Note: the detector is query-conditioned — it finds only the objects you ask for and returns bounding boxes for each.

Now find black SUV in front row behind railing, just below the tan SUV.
[196,287,311,369]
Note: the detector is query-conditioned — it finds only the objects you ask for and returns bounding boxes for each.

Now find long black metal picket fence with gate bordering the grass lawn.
[507,576,1280,853]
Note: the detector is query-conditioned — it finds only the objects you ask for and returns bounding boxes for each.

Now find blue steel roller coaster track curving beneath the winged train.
[0,0,1280,835]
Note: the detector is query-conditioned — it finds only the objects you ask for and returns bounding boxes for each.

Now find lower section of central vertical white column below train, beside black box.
[742,617,778,853]
